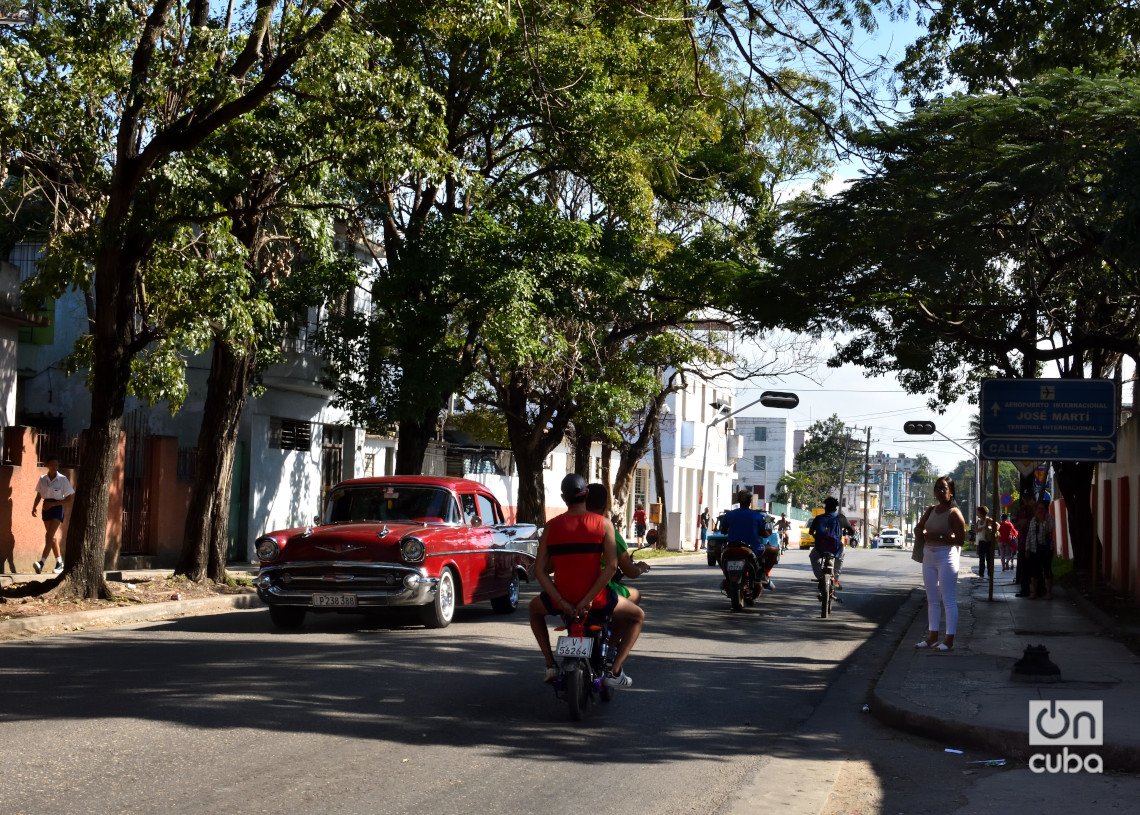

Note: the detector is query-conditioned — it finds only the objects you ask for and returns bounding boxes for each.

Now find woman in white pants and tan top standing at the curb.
[914,475,966,651]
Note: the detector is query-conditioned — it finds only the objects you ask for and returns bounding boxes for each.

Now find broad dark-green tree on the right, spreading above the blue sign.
[780,72,1140,567]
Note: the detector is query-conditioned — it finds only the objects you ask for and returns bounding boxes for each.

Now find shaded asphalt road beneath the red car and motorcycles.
[0,549,915,815]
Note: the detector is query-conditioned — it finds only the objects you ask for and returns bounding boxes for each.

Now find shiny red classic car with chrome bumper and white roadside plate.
[257,475,537,628]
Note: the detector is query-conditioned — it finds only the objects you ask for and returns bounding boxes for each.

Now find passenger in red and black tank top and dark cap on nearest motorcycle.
[530,473,633,687]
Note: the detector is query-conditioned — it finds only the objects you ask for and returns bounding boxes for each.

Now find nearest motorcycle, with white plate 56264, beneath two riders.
[554,610,616,722]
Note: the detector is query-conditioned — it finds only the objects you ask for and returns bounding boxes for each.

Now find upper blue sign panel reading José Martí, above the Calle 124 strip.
[980,380,1116,440]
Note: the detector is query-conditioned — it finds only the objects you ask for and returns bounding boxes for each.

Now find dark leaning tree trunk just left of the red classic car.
[174,341,257,582]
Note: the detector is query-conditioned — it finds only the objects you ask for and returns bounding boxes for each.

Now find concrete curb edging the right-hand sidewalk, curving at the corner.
[871,590,1140,773]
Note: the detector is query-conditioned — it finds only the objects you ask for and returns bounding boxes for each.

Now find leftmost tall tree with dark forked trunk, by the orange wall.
[0,0,360,597]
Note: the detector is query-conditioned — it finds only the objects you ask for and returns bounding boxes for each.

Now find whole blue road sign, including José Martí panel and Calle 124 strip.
[979,380,1116,462]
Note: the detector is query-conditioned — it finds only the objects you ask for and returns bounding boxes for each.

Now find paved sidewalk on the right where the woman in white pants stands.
[871,557,1140,773]
